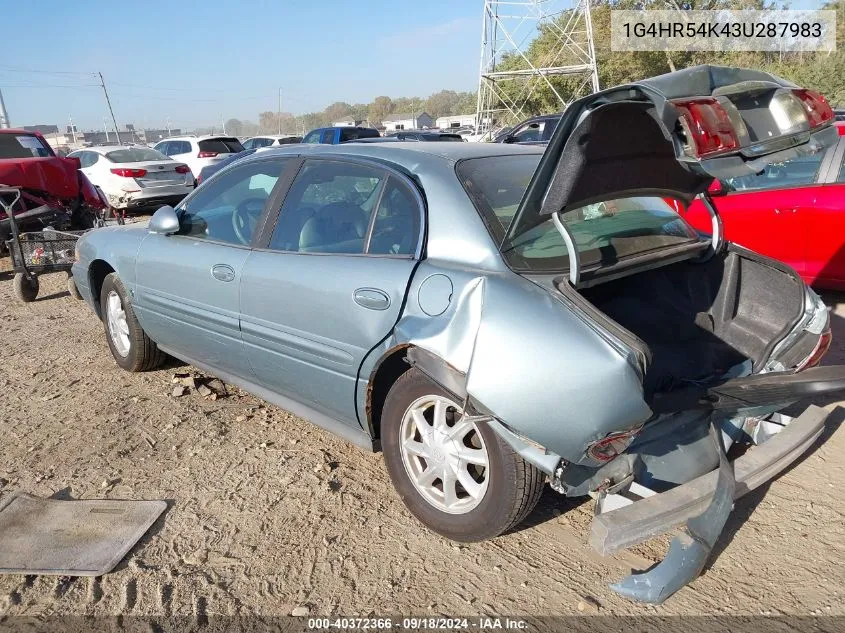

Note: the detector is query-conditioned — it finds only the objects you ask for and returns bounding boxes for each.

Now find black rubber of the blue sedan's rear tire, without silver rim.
[381,369,546,542]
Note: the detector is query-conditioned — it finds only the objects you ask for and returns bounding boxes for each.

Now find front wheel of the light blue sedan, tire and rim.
[100,273,165,372]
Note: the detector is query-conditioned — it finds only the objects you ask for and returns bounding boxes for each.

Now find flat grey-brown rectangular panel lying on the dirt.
[0,493,167,576]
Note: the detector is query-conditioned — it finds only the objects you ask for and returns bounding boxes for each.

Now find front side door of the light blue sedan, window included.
[133,158,286,378]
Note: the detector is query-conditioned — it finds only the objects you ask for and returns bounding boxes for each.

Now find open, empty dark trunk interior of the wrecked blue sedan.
[578,246,804,397]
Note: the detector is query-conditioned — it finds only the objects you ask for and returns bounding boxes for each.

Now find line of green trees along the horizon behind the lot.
[214,0,845,135]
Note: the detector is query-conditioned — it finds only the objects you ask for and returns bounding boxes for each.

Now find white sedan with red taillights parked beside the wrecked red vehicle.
[69,145,194,209]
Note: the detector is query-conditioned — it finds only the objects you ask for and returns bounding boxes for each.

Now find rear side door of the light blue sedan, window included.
[241,159,424,430]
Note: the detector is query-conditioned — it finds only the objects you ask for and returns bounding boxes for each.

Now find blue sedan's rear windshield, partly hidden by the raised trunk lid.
[457,154,699,272]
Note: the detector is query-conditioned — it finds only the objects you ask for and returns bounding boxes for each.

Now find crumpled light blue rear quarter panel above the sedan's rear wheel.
[359,260,652,465]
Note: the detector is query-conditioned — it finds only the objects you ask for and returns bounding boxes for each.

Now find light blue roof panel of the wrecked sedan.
[239,141,543,169]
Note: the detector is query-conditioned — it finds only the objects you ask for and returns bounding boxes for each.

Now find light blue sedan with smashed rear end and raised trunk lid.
[73,67,845,602]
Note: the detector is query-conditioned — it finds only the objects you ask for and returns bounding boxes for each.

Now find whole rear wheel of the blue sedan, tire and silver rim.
[381,369,545,542]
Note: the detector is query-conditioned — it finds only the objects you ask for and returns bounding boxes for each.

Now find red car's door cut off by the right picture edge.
[802,138,845,290]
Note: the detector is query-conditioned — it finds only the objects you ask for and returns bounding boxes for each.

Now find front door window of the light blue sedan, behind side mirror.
[179,159,289,245]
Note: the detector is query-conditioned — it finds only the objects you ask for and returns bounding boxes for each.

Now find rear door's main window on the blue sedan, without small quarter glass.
[270,160,385,254]
